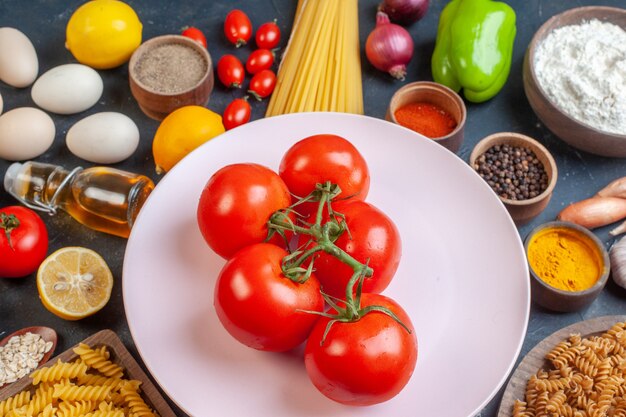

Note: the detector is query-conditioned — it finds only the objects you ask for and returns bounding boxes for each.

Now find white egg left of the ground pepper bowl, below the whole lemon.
[31,64,103,114]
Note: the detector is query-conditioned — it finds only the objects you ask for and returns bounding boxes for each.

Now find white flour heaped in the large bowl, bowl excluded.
[535,20,626,134]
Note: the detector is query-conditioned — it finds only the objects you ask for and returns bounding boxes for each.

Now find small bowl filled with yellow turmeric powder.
[524,221,611,312]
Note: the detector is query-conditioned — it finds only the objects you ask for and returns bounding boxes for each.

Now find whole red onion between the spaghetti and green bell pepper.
[365,12,413,80]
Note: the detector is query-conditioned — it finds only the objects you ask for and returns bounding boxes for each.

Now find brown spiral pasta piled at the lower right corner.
[513,322,626,417]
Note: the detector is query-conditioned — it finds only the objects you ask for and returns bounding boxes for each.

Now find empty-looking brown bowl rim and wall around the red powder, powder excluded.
[386,81,467,152]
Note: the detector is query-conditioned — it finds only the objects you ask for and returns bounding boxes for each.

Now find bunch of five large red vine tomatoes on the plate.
[197,134,417,405]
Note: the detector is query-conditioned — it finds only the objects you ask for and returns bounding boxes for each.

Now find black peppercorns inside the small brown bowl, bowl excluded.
[474,144,549,200]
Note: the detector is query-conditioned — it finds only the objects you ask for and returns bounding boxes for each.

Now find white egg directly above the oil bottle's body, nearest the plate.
[65,112,139,164]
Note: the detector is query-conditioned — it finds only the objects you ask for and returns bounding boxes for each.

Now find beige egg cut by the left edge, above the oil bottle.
[0,107,56,161]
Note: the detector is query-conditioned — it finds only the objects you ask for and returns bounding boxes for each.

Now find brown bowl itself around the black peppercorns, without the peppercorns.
[469,132,557,226]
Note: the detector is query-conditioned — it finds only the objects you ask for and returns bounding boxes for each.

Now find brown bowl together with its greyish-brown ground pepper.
[128,35,214,120]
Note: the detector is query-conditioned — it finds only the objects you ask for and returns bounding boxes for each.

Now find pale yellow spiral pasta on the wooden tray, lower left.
[0,344,158,417]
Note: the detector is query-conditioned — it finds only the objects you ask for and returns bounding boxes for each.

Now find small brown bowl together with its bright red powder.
[386,81,467,152]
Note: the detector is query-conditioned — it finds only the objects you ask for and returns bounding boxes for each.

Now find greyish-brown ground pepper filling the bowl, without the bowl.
[135,43,207,94]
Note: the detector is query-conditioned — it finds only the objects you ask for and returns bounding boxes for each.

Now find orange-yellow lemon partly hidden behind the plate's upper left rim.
[152,106,225,174]
